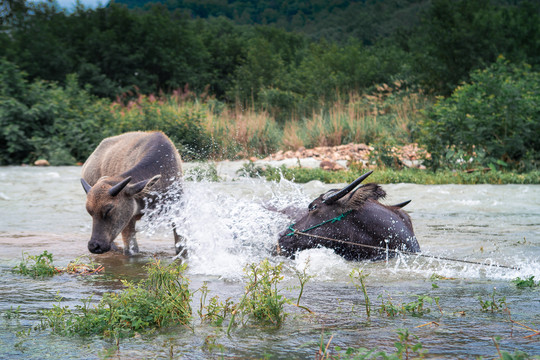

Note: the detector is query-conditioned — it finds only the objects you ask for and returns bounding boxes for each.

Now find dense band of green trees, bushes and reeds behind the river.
[0,0,540,170]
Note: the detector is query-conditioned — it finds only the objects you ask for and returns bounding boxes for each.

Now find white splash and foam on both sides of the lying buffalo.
[143,179,540,281]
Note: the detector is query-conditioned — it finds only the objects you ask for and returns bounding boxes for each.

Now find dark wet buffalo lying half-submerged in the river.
[277,171,420,260]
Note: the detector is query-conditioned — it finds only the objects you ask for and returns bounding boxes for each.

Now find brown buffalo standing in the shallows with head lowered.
[81,132,182,255]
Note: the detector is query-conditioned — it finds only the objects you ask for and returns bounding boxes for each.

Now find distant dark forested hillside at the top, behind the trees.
[114,0,429,44]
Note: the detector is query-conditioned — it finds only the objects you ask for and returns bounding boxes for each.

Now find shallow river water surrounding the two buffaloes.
[0,162,540,359]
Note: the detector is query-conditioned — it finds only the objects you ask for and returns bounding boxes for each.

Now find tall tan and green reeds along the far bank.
[107,83,430,159]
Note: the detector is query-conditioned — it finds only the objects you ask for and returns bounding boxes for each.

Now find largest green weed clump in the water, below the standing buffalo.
[38,261,192,339]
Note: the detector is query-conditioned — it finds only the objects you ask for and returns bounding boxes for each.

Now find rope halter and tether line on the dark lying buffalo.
[284,218,521,270]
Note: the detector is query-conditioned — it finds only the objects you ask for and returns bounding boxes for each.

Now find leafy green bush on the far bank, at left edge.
[0,59,111,165]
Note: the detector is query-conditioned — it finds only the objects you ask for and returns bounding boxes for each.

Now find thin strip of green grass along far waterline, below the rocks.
[245,165,540,185]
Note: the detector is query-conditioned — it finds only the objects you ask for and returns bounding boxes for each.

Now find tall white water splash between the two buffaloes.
[143,179,307,279]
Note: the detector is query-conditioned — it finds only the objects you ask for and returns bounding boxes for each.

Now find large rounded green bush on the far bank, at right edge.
[420,57,540,171]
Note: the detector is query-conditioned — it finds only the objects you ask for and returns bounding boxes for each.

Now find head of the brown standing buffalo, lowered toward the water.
[81,175,160,254]
